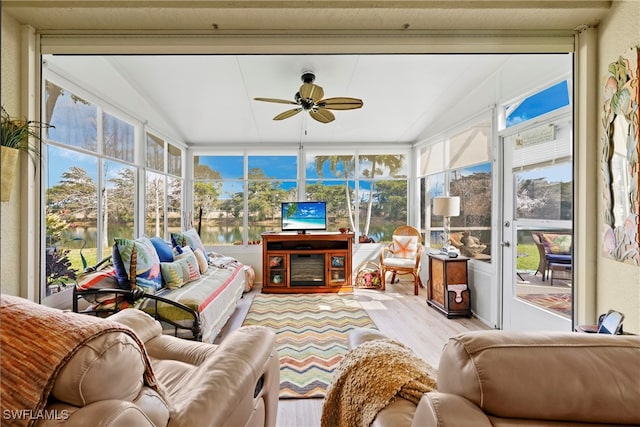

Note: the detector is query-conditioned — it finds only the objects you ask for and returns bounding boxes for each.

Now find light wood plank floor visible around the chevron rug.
[216,281,489,427]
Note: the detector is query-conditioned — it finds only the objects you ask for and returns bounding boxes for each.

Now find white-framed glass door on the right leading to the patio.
[501,114,573,331]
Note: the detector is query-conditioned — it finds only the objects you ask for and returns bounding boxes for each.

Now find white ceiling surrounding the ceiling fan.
[47,55,552,146]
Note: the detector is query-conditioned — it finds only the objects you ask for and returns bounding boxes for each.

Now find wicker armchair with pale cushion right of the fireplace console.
[380,225,423,295]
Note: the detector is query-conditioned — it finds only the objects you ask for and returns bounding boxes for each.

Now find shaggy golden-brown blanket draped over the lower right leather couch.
[320,339,436,427]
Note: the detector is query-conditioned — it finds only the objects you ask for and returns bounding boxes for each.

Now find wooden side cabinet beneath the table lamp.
[427,254,471,318]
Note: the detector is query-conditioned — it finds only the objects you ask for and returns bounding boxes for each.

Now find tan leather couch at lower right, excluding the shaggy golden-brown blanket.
[350,329,640,427]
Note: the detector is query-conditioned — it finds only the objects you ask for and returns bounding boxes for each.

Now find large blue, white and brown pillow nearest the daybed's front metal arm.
[113,237,162,293]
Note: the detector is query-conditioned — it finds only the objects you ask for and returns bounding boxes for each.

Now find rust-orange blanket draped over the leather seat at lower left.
[0,295,158,426]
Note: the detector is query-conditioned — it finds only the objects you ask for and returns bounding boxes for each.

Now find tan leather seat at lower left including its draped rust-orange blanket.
[0,295,280,427]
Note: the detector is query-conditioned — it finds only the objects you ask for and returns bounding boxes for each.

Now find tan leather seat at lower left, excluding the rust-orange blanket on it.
[36,309,280,427]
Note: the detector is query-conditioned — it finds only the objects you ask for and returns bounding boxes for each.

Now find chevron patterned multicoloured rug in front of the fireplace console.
[243,294,376,399]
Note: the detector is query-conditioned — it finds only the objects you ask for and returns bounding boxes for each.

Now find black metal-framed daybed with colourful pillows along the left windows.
[73,230,254,342]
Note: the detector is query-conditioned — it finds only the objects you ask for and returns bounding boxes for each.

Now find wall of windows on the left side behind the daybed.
[43,80,183,295]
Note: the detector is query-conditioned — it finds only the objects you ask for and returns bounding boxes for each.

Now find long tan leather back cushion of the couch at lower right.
[438,331,640,425]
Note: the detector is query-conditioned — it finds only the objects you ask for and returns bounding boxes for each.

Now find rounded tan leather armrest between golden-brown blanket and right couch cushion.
[411,392,492,427]
